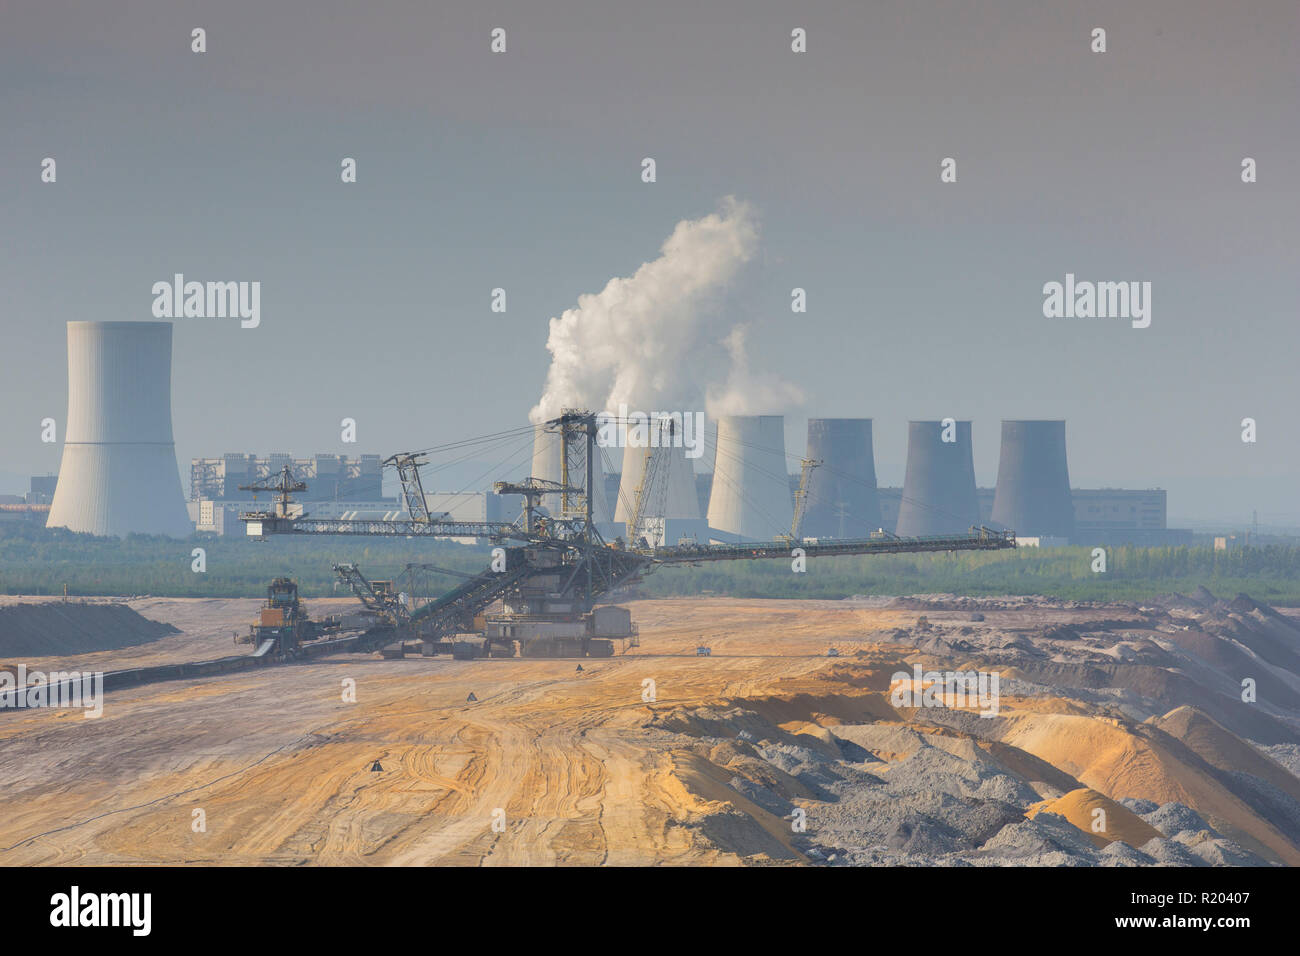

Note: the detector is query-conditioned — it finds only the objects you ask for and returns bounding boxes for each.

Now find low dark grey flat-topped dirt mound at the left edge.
[0,601,179,658]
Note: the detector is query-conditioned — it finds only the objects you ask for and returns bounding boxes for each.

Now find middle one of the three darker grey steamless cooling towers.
[896,421,979,537]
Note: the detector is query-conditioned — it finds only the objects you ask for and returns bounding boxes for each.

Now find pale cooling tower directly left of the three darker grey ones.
[709,415,794,541]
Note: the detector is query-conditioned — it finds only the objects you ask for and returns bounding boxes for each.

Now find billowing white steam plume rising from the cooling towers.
[529,196,797,423]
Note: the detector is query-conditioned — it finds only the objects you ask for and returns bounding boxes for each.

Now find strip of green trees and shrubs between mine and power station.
[0,527,1300,605]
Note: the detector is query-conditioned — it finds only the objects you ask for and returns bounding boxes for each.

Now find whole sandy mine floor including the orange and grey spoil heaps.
[0,598,1300,865]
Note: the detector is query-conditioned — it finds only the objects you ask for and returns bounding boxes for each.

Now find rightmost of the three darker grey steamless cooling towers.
[993,421,1074,538]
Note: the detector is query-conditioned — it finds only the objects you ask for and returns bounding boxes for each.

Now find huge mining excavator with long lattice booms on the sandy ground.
[239,410,1015,657]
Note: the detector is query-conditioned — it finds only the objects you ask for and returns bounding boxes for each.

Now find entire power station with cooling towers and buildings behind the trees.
[27,321,1191,548]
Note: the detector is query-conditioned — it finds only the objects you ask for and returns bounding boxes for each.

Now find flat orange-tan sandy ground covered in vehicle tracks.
[0,600,915,865]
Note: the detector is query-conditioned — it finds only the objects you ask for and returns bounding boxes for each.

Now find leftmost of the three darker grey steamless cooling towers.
[800,419,880,538]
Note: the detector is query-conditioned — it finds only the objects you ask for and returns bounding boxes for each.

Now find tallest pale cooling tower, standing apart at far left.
[46,323,194,537]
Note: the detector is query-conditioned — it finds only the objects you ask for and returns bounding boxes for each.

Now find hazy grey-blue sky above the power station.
[0,0,1300,525]
